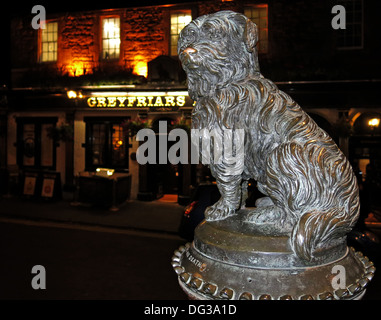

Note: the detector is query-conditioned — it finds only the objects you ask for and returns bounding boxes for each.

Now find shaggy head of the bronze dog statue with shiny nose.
[178,11,259,100]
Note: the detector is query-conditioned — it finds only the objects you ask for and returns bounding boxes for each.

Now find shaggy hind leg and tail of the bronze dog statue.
[267,143,360,261]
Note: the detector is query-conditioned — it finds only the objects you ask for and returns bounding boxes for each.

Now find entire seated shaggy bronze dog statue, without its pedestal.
[178,11,359,262]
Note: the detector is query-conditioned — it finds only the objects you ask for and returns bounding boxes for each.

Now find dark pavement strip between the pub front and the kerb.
[0,193,184,235]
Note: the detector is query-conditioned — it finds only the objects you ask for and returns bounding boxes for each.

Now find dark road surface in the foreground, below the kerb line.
[0,220,186,300]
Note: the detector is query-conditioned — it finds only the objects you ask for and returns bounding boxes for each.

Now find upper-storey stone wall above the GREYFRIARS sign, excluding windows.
[11,0,381,81]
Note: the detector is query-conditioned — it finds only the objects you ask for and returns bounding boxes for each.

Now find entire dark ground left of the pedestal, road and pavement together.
[0,194,186,300]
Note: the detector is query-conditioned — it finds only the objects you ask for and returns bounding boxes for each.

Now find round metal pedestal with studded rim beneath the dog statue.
[172,210,375,300]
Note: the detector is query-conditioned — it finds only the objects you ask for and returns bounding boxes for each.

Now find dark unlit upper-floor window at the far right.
[337,0,363,49]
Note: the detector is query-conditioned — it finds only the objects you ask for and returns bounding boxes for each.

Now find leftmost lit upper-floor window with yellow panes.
[40,22,58,62]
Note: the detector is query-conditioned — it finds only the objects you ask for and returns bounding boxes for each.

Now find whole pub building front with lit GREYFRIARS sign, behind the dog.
[5,0,381,208]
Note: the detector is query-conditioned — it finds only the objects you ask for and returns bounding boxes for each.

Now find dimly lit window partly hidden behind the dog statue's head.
[245,4,269,53]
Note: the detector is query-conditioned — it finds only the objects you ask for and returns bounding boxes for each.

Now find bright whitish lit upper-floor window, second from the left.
[102,17,120,59]
